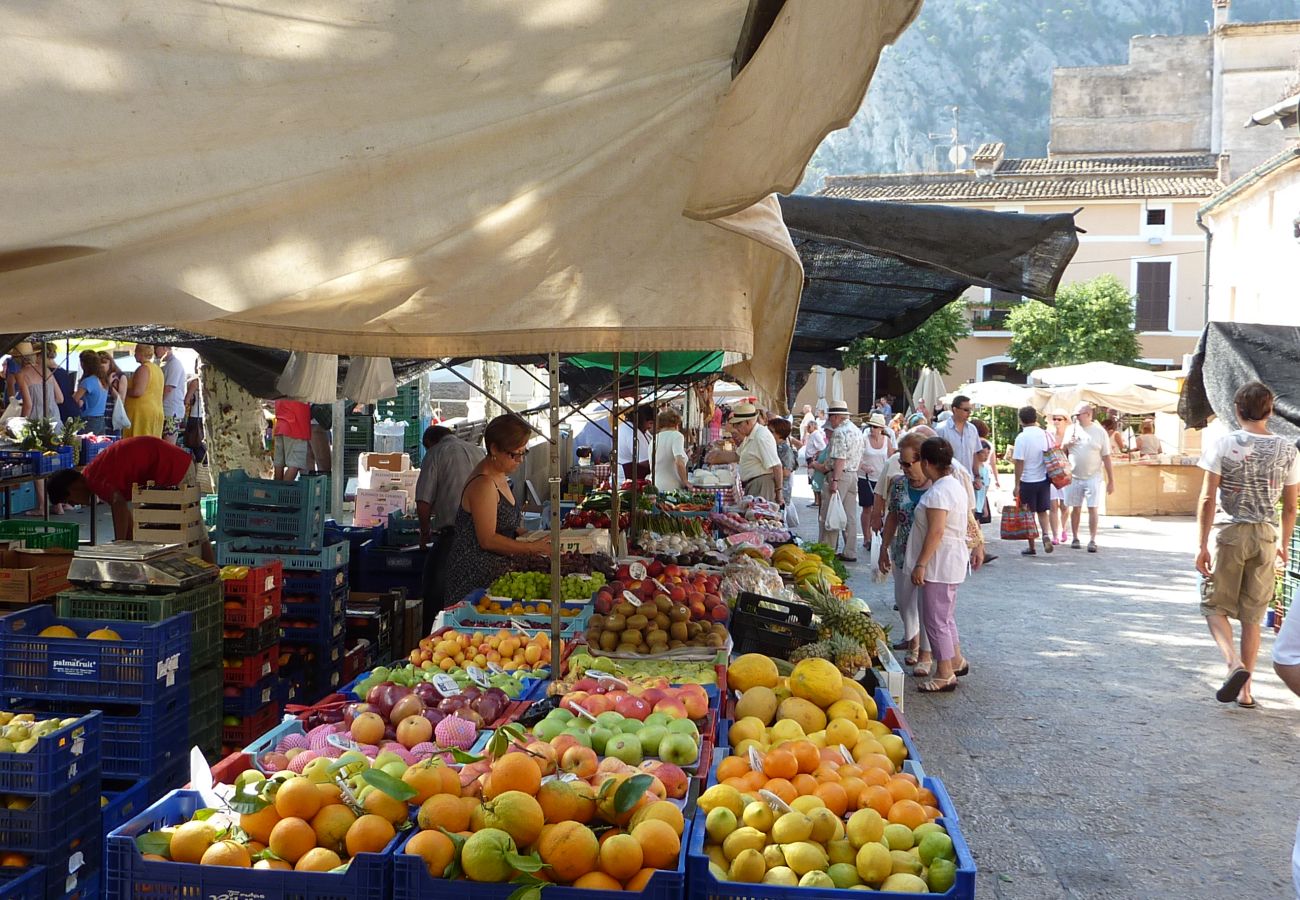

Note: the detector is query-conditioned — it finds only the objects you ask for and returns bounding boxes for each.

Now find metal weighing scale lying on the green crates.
[68,541,220,593]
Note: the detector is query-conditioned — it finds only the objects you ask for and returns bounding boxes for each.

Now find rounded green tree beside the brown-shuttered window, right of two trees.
[1006,274,1140,372]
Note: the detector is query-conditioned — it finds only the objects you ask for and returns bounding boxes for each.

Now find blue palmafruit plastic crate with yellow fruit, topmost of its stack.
[0,606,192,704]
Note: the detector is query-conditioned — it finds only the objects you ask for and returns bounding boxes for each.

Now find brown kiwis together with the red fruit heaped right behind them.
[586,562,731,654]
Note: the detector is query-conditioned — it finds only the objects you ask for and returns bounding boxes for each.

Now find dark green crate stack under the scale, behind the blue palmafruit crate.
[57,566,222,758]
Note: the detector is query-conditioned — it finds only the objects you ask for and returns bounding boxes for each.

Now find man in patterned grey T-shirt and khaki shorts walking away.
[1196,381,1300,709]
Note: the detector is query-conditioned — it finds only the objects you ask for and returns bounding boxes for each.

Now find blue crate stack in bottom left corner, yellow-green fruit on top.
[0,710,103,900]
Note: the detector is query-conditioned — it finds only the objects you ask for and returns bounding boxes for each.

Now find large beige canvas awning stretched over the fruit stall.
[0,0,920,397]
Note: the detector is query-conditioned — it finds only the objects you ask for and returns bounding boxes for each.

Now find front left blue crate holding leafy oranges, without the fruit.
[105,791,404,900]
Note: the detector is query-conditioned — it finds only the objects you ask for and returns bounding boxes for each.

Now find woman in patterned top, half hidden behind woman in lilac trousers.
[879,433,933,678]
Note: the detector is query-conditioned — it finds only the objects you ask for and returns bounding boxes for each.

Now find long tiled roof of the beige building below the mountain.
[818,154,1223,203]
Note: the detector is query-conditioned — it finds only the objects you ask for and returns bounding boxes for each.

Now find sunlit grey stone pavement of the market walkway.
[797,488,1300,900]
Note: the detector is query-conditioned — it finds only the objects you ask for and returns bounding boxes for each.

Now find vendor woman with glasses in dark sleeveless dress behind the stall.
[447,415,538,602]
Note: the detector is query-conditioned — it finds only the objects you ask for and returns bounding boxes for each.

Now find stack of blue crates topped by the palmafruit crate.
[0,606,192,806]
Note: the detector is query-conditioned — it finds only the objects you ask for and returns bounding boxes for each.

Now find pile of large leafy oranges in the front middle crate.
[399,732,685,891]
